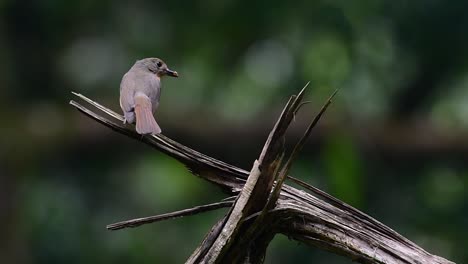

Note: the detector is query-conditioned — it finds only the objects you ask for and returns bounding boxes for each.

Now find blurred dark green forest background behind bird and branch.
[0,0,468,263]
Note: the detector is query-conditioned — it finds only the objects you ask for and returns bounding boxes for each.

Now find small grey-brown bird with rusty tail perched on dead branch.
[120,58,179,135]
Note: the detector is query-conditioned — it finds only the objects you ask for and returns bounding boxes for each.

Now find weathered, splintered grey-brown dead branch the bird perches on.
[71,91,452,263]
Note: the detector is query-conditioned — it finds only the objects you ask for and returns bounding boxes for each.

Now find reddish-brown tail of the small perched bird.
[135,95,161,135]
